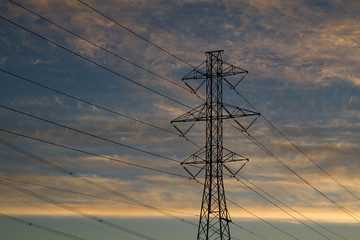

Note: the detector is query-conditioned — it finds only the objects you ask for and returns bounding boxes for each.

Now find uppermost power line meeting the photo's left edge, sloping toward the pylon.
[0,15,191,108]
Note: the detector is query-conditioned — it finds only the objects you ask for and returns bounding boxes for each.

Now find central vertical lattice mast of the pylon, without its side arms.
[198,51,230,239]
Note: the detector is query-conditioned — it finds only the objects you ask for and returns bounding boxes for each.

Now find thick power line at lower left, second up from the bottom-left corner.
[0,179,155,240]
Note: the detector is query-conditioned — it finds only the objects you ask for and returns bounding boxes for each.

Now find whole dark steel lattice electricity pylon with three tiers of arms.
[171,50,259,240]
